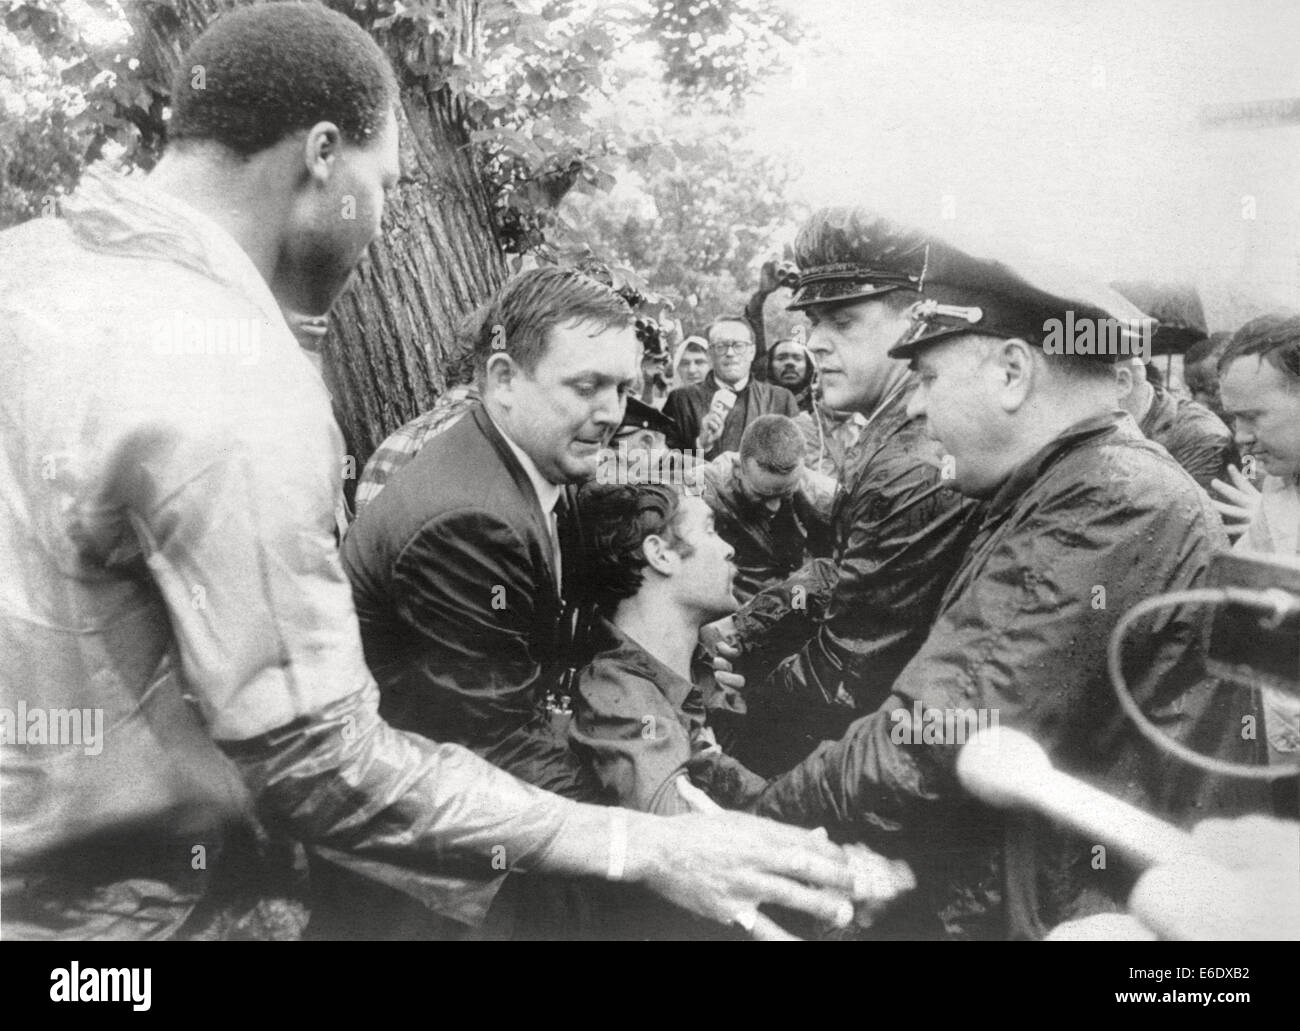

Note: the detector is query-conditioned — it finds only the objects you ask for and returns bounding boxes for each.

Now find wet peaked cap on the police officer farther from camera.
[787,208,927,311]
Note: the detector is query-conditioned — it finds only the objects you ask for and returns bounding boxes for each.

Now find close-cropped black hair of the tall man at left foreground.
[168,3,398,157]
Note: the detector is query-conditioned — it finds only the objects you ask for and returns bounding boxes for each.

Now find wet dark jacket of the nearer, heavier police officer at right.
[755,413,1262,937]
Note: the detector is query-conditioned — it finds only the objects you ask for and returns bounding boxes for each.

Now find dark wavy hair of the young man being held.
[579,481,694,612]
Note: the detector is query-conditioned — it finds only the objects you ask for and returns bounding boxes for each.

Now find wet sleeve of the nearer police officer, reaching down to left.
[755,478,1204,831]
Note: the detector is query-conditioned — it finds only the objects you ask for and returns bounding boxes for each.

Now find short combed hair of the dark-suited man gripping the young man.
[475,267,633,376]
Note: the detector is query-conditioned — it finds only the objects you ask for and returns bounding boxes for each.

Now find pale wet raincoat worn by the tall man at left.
[0,169,582,937]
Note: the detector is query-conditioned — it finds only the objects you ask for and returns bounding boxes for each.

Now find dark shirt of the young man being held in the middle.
[569,619,766,816]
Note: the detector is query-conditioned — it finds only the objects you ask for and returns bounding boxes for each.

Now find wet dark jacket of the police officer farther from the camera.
[736,381,979,711]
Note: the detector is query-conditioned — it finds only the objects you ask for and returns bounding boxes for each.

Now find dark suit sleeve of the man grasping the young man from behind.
[393,508,593,798]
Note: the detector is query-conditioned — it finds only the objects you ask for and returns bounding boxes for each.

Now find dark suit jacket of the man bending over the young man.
[343,406,598,800]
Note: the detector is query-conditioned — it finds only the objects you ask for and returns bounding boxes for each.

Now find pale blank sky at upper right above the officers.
[745,0,1300,329]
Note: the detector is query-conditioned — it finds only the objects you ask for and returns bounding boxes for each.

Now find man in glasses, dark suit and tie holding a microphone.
[663,316,800,460]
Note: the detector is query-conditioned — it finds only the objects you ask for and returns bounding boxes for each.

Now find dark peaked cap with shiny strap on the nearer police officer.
[889,241,1156,364]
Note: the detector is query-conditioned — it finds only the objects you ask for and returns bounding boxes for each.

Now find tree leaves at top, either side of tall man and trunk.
[0,0,797,296]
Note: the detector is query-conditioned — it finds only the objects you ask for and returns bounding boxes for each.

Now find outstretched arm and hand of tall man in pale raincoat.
[129,408,852,922]
